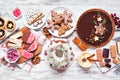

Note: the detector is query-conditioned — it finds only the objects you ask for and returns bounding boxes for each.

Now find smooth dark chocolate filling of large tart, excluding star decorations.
[77,11,112,46]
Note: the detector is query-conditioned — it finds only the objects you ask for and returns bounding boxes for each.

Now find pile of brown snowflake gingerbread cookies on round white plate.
[46,10,73,36]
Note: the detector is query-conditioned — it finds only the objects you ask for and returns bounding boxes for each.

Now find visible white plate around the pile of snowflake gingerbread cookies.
[46,7,76,37]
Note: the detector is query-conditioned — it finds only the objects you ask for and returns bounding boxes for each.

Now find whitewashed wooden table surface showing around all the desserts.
[0,0,120,80]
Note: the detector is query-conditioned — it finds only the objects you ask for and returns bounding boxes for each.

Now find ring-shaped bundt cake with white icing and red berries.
[44,40,74,72]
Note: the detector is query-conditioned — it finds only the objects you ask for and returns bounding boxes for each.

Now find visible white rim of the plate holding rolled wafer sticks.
[22,7,45,30]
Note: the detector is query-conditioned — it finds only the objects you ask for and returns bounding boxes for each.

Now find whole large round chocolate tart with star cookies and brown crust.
[76,9,114,47]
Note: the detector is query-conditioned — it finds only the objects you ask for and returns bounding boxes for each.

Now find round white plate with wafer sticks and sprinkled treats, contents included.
[22,7,45,30]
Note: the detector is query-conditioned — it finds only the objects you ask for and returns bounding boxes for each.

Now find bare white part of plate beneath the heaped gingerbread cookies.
[46,7,76,37]
